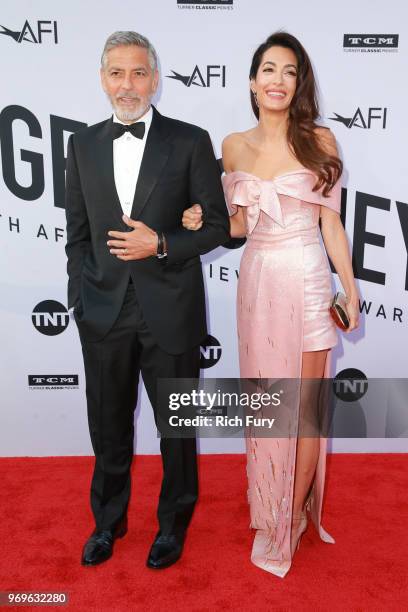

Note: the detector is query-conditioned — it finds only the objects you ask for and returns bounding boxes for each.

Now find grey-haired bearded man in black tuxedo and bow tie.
[66,32,229,568]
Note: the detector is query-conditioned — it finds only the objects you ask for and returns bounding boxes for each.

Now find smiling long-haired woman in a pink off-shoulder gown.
[183,32,358,577]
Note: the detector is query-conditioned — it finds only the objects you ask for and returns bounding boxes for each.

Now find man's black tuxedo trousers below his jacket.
[81,283,200,535]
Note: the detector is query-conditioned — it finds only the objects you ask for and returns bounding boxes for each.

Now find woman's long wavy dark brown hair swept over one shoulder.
[249,32,343,196]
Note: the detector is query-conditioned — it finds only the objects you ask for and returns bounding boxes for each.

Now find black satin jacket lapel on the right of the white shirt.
[131,107,170,220]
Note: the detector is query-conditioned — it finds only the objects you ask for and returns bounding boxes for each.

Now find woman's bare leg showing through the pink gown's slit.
[292,350,327,520]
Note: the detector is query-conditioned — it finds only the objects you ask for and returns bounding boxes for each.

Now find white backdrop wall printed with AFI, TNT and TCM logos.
[0,0,408,456]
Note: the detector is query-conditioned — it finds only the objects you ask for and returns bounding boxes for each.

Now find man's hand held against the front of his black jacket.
[107,215,158,261]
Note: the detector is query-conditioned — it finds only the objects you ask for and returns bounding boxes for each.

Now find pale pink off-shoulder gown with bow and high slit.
[223,169,341,577]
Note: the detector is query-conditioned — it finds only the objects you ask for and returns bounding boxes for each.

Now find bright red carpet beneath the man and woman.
[0,454,408,612]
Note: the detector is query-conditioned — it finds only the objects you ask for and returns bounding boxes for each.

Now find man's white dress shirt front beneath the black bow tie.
[113,107,153,217]
